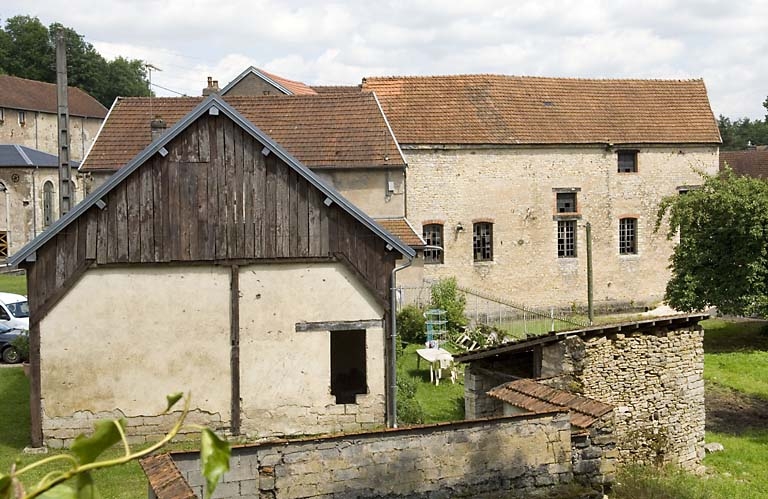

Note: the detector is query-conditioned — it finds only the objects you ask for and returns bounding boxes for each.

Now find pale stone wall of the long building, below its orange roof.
[405,146,718,307]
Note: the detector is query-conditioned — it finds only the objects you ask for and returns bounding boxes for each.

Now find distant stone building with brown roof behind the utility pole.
[0,75,107,161]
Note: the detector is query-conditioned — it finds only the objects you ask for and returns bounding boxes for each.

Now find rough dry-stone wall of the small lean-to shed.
[542,326,704,469]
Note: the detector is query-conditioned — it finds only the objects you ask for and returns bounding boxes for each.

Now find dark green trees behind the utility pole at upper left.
[0,16,150,107]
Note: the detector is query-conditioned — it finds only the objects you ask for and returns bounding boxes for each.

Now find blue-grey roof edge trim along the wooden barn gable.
[8,95,415,266]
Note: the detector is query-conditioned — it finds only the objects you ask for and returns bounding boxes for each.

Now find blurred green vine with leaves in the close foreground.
[0,394,230,499]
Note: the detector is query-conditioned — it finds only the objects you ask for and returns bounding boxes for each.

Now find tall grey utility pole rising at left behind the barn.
[56,28,72,217]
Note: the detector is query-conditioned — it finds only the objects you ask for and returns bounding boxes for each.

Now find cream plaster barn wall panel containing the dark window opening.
[240,263,385,436]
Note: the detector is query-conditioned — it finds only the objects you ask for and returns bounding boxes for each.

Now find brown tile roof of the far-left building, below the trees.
[0,75,107,118]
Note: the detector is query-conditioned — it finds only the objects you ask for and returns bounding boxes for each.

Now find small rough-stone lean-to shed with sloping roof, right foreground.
[456,314,708,470]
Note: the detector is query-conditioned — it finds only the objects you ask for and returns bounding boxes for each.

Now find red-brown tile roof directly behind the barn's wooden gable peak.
[81,94,405,171]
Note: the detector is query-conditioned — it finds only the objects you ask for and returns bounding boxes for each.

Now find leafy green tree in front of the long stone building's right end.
[656,170,768,316]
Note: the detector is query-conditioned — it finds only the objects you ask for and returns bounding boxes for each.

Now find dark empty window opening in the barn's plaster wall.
[331,329,368,404]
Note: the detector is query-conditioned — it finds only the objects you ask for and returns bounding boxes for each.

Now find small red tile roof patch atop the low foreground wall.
[488,379,613,428]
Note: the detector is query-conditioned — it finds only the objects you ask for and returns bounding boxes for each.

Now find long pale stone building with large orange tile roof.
[362,75,720,308]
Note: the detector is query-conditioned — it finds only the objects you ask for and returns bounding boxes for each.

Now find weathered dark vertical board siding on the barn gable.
[26,115,395,321]
